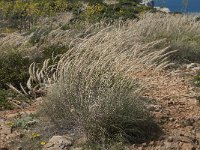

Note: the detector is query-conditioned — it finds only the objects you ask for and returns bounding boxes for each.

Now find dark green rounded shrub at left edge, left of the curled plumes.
[0,51,30,88]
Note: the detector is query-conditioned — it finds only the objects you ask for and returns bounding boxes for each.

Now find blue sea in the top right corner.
[155,0,200,13]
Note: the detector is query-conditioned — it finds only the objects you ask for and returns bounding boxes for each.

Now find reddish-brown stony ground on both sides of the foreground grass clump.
[0,64,200,150]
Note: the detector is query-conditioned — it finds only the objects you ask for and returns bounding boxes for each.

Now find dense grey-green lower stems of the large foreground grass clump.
[43,69,157,143]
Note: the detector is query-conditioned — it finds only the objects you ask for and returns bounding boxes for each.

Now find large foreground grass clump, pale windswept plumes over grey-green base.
[40,20,168,142]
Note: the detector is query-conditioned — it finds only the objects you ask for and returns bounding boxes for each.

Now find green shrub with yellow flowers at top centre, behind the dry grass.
[73,0,152,23]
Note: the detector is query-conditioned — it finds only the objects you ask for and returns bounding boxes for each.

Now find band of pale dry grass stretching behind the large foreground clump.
[0,13,200,63]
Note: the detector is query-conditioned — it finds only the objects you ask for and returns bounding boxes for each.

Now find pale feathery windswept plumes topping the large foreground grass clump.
[28,18,176,93]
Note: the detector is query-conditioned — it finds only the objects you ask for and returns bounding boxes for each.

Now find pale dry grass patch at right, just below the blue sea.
[131,13,200,63]
